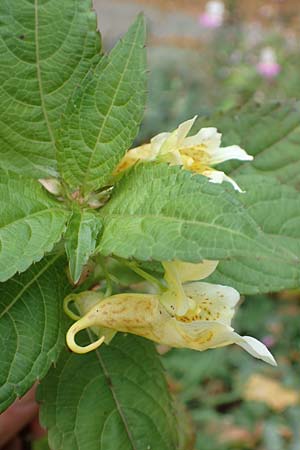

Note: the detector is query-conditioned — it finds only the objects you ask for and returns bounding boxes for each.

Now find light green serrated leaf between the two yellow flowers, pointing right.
[99,164,290,262]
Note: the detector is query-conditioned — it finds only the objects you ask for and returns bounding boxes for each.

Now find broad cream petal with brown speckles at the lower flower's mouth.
[184,282,240,325]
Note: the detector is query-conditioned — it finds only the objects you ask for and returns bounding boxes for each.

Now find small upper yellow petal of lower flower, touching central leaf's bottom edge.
[172,260,219,283]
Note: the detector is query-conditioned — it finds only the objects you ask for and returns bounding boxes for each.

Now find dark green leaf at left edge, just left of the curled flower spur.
[0,256,67,411]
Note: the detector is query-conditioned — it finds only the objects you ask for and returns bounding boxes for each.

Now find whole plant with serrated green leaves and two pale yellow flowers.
[0,0,300,450]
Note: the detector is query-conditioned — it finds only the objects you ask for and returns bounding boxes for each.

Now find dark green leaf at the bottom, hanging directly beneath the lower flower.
[38,334,177,450]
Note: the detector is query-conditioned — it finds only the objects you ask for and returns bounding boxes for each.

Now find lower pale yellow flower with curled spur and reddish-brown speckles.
[67,262,276,365]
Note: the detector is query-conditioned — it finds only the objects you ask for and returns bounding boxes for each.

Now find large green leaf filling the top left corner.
[0,0,100,178]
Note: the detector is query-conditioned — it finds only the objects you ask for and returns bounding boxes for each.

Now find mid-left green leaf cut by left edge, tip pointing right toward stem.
[0,171,70,281]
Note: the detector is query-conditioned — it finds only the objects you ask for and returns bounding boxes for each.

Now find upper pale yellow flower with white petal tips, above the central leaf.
[114,116,253,192]
